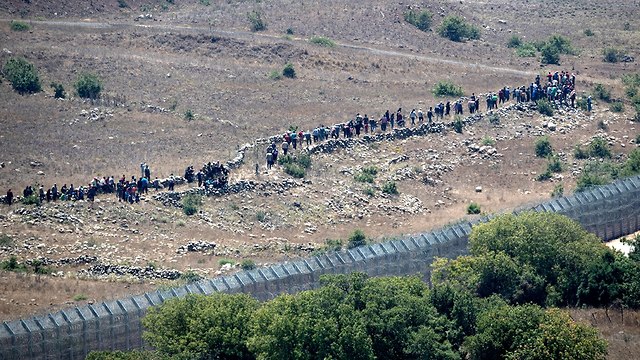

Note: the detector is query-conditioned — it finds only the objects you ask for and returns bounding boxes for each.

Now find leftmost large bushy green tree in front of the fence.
[142,293,258,360]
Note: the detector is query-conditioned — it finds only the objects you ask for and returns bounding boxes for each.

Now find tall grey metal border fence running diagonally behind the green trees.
[0,176,640,360]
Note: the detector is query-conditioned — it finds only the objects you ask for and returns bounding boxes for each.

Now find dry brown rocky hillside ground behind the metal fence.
[0,0,640,359]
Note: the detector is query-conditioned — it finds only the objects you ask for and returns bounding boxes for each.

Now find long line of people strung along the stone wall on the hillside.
[5,71,591,205]
